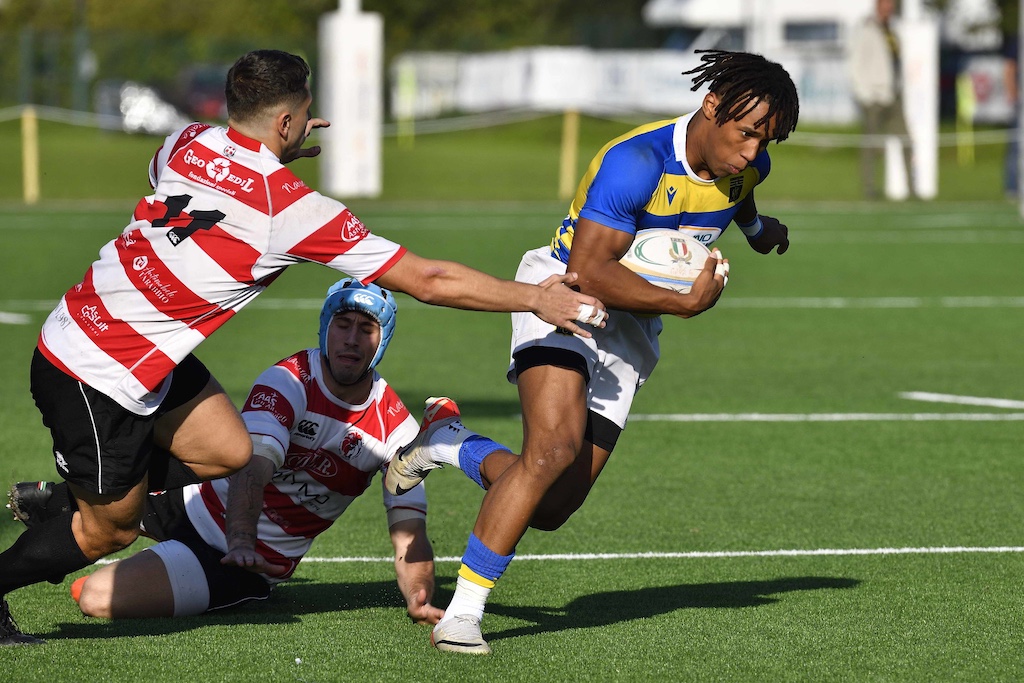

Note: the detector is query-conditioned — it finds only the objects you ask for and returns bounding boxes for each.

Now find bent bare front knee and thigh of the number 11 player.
[154,377,252,480]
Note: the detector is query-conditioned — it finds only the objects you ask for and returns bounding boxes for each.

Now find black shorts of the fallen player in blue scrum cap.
[142,488,272,611]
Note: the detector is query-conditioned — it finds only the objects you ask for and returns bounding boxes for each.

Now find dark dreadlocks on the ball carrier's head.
[683,50,800,142]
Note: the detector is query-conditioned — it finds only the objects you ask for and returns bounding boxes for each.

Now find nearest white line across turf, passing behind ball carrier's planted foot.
[302,546,1024,563]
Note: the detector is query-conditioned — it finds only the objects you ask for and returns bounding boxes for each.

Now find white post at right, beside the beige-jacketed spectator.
[886,11,939,200]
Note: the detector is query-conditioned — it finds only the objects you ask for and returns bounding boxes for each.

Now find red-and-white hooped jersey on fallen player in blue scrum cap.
[184,348,427,582]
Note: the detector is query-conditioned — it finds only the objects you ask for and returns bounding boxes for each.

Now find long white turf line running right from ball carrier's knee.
[629,413,1024,422]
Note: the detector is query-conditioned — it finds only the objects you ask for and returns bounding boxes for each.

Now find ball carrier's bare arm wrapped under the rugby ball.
[568,218,729,317]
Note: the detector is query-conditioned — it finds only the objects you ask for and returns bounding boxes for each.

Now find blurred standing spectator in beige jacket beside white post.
[850,0,914,200]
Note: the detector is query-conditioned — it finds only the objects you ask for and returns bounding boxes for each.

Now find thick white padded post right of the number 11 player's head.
[313,0,384,198]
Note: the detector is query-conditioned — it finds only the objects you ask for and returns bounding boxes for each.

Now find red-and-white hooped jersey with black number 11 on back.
[39,124,406,415]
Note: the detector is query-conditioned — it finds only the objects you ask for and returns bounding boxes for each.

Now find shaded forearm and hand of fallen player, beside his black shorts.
[220,454,286,575]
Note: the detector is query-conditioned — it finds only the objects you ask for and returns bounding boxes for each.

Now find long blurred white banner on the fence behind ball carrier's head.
[391,47,857,124]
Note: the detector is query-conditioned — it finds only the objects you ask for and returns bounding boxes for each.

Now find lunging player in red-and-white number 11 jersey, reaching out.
[0,50,604,645]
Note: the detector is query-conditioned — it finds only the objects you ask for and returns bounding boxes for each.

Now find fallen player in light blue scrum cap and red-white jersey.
[52,279,442,624]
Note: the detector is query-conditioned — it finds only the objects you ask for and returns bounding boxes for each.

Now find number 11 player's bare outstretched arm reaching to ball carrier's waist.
[377,252,605,337]
